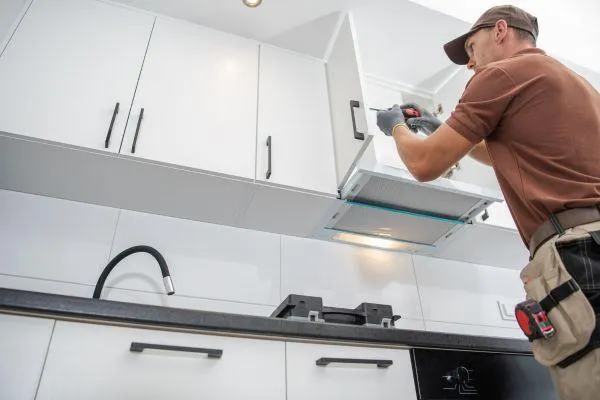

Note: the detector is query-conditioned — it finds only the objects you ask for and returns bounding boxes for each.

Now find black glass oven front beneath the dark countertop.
[411,349,558,400]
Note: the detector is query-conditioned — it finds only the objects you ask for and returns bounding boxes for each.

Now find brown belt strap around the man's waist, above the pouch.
[529,204,600,259]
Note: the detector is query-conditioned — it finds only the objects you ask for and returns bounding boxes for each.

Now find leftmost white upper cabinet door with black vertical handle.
[0,0,153,151]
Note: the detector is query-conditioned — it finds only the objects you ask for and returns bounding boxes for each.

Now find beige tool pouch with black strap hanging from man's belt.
[521,227,600,367]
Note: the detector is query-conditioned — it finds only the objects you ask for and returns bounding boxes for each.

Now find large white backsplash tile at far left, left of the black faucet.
[0,190,119,286]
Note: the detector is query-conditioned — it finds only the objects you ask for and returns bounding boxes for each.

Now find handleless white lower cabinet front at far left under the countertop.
[0,314,54,400]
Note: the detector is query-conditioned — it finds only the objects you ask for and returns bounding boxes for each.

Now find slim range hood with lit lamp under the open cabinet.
[316,135,502,254]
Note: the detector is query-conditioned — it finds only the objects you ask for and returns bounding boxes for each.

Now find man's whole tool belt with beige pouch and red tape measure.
[515,206,600,368]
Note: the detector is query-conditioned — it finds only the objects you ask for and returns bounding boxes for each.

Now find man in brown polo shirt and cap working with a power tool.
[377,6,600,400]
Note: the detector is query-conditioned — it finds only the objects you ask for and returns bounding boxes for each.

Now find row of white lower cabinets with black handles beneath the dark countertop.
[11,315,424,400]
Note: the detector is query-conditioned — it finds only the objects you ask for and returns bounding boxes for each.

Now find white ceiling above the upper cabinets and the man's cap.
[113,0,600,92]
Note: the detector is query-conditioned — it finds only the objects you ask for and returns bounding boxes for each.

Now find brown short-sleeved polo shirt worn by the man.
[446,49,600,245]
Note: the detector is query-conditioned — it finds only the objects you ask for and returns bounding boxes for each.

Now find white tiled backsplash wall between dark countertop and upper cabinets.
[0,191,522,337]
